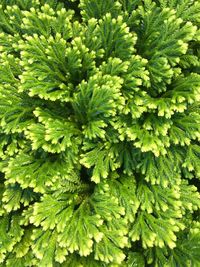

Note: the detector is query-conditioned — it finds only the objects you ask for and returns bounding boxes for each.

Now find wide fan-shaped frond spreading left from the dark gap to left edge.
[3,153,79,193]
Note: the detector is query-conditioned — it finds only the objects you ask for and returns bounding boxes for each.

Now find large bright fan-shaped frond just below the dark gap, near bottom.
[30,195,103,258]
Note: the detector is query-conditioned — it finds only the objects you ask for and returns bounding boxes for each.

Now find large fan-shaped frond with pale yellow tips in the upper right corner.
[138,5,197,66]
